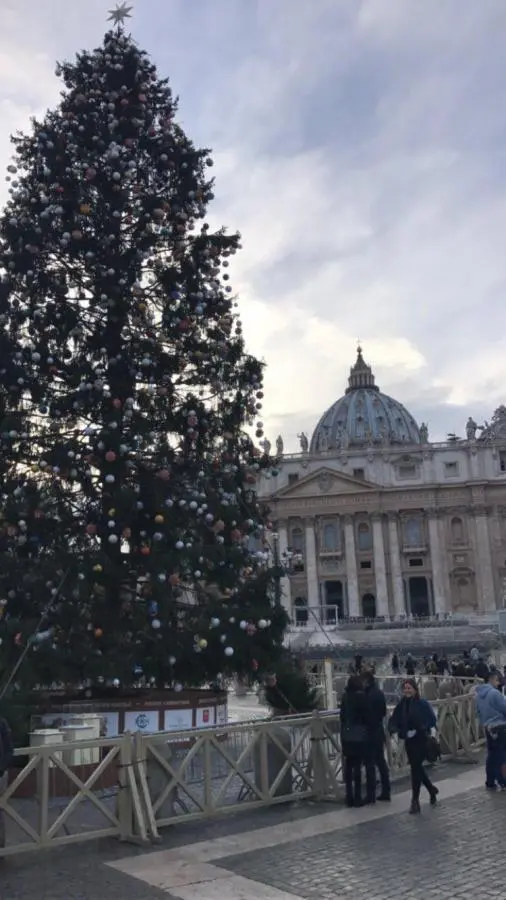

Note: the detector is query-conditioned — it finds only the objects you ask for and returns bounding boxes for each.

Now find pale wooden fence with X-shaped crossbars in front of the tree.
[0,695,481,857]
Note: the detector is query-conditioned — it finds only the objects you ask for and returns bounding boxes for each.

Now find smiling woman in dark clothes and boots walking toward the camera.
[388,678,439,815]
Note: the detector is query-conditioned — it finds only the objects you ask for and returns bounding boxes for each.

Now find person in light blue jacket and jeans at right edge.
[475,670,506,791]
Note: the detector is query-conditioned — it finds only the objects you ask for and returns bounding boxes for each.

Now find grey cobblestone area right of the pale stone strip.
[219,788,506,900]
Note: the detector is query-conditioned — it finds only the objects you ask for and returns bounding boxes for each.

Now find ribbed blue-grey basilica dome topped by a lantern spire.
[310,347,422,453]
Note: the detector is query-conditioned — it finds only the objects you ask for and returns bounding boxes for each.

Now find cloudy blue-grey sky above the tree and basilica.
[0,0,506,449]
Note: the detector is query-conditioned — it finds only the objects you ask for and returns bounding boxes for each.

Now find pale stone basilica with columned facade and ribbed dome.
[258,348,506,625]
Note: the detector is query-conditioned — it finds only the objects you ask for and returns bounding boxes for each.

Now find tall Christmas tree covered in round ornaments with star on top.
[0,5,286,688]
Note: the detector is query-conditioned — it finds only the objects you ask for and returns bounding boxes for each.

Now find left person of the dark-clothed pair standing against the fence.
[340,675,376,806]
